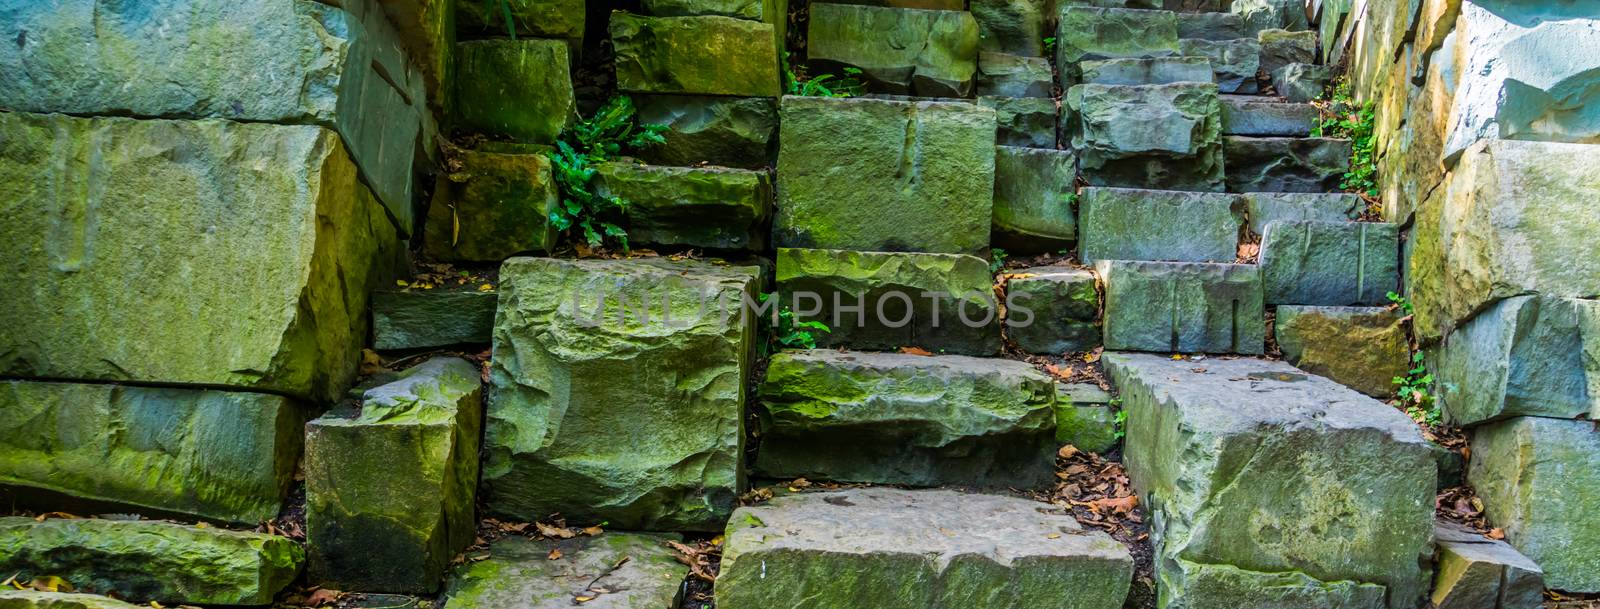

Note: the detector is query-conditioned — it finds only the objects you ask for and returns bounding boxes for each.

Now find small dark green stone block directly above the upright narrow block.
[373,285,494,350]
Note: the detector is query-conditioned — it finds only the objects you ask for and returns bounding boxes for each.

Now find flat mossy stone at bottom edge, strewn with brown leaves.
[445,532,688,609]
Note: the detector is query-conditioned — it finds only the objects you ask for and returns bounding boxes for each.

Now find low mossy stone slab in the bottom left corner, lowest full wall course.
[0,516,304,604]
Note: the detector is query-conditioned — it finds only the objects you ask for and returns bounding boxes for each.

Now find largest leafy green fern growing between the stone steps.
[546,96,667,249]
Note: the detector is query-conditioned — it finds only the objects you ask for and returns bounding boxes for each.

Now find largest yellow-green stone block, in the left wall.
[0,112,400,400]
